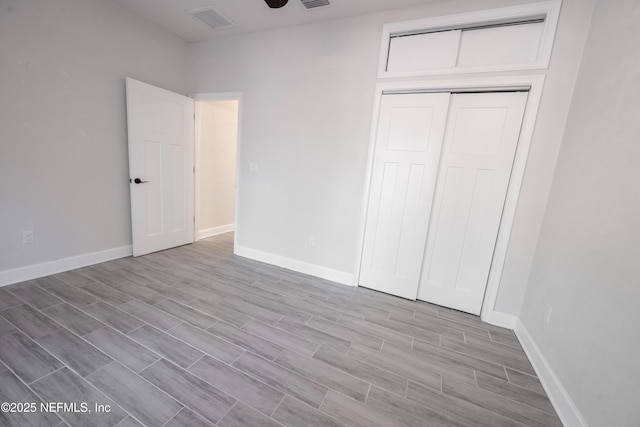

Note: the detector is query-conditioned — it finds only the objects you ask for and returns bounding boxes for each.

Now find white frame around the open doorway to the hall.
[189,92,243,248]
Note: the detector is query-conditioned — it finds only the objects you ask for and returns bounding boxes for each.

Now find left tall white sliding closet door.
[360,93,450,299]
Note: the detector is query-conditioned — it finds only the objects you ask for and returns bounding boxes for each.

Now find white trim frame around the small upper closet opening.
[378,0,562,79]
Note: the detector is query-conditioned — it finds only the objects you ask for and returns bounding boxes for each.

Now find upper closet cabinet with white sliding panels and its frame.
[378,0,560,78]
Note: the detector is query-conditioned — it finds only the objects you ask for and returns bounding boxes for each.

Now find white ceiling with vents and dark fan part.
[116,0,439,42]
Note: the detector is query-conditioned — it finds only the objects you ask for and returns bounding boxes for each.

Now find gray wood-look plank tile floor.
[0,234,561,427]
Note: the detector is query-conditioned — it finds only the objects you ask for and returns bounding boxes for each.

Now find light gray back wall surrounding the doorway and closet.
[189,0,593,315]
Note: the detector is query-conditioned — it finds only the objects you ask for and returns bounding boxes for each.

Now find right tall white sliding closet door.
[418,92,527,314]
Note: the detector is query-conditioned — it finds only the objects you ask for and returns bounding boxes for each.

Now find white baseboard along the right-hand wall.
[515,319,588,427]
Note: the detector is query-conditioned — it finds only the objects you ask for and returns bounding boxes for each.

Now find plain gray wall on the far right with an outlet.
[521,0,640,427]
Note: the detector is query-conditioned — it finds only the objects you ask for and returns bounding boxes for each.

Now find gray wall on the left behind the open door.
[0,0,188,272]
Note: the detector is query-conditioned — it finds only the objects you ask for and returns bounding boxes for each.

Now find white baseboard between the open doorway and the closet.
[234,245,354,286]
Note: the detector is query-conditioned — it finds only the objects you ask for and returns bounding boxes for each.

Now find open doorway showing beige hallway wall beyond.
[194,93,241,246]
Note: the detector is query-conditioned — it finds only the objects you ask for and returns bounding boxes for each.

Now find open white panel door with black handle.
[127,79,194,256]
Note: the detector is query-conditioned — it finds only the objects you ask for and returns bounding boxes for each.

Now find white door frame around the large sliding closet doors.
[354,75,545,326]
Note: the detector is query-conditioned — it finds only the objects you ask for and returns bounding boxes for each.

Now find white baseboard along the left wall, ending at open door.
[0,245,133,286]
